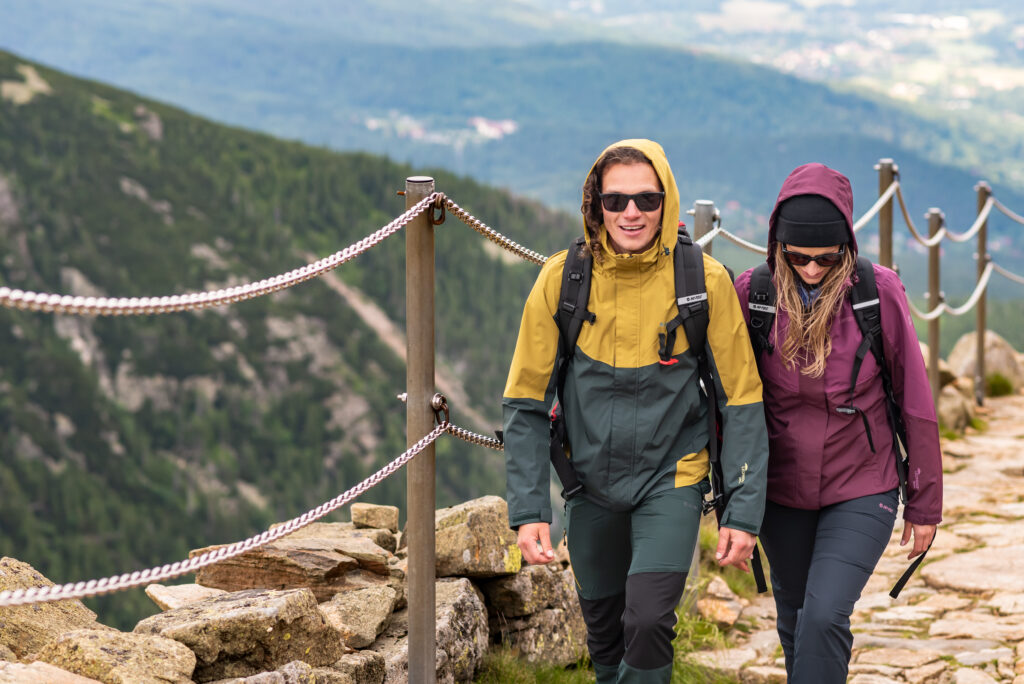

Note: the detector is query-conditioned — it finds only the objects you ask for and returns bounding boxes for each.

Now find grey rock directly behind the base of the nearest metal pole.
[372,578,488,684]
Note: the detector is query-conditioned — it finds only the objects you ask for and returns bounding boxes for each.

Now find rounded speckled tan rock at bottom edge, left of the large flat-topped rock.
[37,630,196,684]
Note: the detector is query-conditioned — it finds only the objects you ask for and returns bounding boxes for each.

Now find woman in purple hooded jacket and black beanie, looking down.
[736,164,942,684]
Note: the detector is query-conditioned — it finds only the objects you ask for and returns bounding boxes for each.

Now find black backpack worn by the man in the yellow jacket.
[550,228,768,593]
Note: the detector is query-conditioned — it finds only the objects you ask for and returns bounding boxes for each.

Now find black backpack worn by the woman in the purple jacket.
[748,256,934,598]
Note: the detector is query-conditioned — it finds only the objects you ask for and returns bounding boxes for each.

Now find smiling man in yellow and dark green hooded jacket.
[502,140,768,683]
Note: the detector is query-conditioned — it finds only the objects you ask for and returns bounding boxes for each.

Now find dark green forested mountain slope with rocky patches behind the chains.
[0,52,577,622]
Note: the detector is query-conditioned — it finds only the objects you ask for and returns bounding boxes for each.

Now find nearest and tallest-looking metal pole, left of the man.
[406,176,437,684]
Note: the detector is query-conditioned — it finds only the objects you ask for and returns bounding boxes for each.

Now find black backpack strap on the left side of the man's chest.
[549,236,596,501]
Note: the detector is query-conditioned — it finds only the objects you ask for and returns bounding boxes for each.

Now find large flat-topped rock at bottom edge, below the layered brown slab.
[135,589,342,682]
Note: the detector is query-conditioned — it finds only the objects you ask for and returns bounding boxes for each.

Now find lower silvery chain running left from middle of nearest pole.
[0,421,450,607]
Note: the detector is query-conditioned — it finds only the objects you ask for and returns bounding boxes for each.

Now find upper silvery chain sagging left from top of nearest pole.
[0,193,443,315]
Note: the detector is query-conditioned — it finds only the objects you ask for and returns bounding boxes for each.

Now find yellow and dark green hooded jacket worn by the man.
[502,140,768,535]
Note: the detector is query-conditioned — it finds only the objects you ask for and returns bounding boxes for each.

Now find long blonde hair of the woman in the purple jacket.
[773,243,857,378]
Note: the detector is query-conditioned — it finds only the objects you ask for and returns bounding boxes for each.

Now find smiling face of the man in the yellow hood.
[601,164,665,254]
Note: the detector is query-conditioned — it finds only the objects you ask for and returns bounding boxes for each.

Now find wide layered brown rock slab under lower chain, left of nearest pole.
[188,523,394,601]
